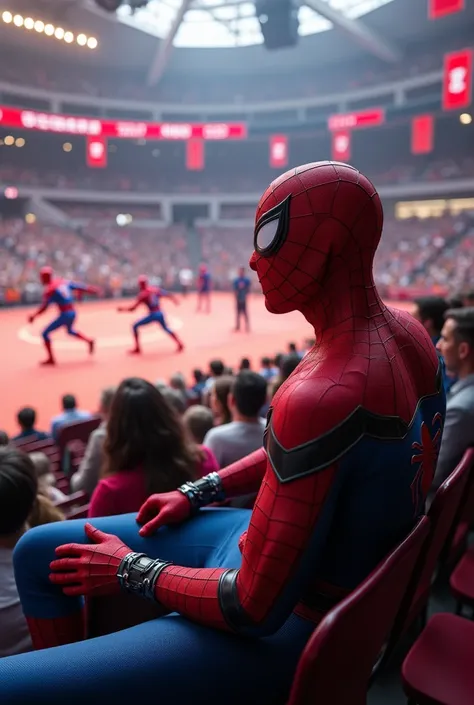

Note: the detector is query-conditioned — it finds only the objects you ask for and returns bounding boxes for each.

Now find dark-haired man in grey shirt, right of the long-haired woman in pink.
[204,370,267,468]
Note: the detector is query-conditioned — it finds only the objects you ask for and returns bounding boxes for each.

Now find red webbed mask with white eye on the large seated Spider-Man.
[250,162,383,313]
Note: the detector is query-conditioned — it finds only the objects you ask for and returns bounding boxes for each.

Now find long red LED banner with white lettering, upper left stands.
[0,106,247,140]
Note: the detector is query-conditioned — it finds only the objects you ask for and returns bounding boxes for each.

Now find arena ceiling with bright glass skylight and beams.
[0,0,474,77]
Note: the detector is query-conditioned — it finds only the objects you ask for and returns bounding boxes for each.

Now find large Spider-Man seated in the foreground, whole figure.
[0,162,445,705]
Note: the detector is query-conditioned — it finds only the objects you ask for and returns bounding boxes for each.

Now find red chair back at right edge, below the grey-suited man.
[405,449,474,628]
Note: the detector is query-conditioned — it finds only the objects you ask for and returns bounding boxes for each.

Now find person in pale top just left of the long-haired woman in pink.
[71,387,115,495]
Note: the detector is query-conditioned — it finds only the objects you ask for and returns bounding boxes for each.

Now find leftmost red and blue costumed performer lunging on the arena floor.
[28,267,100,365]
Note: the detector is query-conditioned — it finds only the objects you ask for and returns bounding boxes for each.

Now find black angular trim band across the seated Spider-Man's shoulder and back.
[266,366,442,483]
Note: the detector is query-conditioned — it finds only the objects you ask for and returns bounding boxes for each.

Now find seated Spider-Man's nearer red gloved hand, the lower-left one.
[49,524,132,597]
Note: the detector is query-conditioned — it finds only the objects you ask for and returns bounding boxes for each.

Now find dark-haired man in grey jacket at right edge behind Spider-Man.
[431,307,474,494]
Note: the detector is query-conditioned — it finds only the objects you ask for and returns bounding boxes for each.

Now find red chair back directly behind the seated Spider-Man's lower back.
[288,517,430,705]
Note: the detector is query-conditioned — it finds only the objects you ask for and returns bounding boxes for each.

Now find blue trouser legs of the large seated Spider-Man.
[0,510,313,705]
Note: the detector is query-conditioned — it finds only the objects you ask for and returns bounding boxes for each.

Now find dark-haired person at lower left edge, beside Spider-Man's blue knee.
[0,447,37,658]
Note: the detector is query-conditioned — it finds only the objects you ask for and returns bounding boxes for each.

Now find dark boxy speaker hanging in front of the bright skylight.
[255,0,299,50]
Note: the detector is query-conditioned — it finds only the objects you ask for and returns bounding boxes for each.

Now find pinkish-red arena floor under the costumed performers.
[0,294,412,433]
